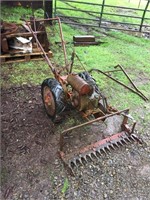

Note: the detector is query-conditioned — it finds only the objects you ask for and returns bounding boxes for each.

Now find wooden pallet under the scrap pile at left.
[0,51,52,64]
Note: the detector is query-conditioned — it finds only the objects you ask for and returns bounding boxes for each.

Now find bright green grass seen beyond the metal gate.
[57,0,150,24]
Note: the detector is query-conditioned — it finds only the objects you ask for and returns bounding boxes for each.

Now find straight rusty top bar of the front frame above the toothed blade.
[62,109,129,134]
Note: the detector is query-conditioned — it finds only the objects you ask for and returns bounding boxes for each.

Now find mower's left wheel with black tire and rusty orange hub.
[41,78,65,121]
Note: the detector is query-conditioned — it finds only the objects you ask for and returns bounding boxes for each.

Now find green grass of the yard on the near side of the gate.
[1,3,150,122]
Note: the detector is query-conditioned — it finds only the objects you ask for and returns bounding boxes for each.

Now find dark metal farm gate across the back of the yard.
[54,0,150,33]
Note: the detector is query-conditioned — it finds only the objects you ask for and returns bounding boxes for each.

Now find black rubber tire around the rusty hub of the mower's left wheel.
[41,78,65,121]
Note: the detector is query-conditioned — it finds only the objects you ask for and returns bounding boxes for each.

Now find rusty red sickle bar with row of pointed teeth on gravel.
[60,131,142,172]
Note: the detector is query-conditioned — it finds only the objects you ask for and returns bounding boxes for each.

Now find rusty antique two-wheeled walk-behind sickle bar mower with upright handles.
[26,18,141,172]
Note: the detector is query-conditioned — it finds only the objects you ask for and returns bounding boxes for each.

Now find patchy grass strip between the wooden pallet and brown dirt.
[1,61,52,87]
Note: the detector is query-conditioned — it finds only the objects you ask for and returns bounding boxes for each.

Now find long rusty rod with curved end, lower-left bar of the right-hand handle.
[89,69,147,101]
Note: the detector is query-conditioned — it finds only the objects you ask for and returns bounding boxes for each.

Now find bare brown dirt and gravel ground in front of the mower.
[1,85,150,200]
